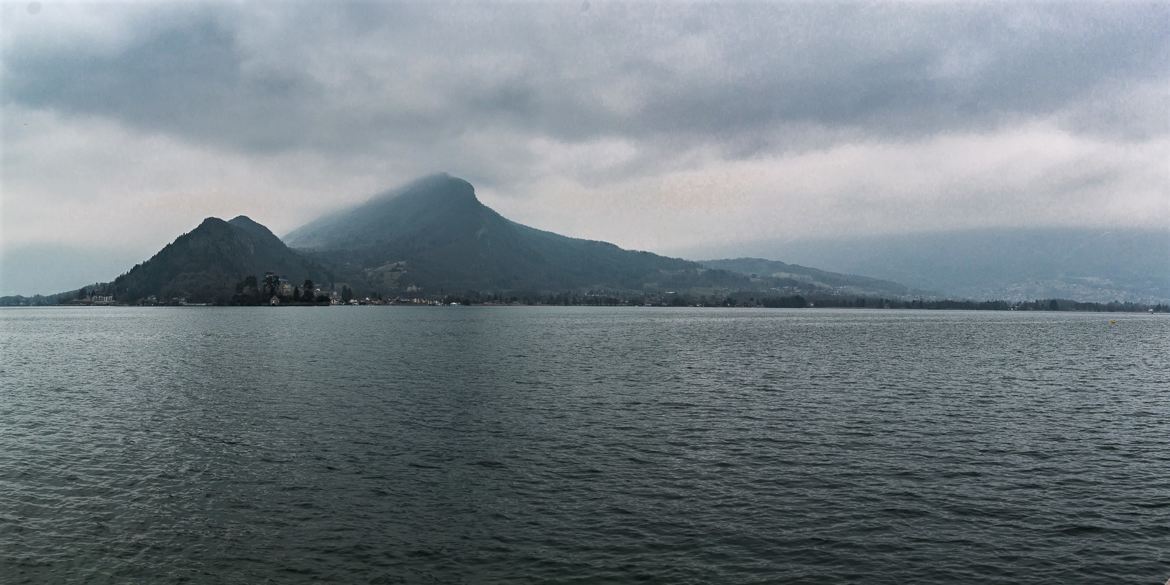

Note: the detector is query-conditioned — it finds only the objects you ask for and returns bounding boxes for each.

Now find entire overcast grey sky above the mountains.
[0,0,1170,294]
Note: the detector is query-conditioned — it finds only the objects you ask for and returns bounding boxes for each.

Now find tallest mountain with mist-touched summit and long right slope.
[285,174,758,293]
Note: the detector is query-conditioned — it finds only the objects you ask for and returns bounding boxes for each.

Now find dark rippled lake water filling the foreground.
[0,307,1170,585]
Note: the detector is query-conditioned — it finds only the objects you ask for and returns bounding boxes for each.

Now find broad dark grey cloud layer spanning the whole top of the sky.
[4,2,1170,160]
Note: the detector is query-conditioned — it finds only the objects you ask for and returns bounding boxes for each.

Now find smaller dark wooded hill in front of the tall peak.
[113,215,331,303]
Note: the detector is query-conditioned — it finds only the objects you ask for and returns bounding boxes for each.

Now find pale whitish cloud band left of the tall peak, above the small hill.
[0,108,407,252]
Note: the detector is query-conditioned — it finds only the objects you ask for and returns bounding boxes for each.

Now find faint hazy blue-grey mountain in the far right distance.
[683,228,1170,303]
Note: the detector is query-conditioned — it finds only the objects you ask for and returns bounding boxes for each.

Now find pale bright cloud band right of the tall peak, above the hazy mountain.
[501,122,1170,252]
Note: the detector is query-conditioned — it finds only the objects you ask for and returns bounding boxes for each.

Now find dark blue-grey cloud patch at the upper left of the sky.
[4,15,324,151]
